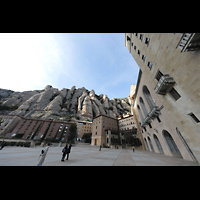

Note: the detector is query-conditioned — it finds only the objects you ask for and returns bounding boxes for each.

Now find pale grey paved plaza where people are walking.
[0,144,199,166]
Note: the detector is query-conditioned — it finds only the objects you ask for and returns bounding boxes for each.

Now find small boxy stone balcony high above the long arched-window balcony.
[154,74,175,95]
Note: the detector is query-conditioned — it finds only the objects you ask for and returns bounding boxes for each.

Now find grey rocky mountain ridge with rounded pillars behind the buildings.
[0,85,131,121]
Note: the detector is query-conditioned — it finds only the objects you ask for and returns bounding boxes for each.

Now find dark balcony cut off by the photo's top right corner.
[176,33,200,52]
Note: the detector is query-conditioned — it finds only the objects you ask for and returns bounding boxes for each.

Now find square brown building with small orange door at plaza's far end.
[91,115,119,146]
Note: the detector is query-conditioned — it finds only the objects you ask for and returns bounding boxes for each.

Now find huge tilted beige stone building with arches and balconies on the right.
[125,33,200,162]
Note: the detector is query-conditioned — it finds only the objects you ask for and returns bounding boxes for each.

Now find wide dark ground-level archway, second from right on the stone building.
[163,130,182,158]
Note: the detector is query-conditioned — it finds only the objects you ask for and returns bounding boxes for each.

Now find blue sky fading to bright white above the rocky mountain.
[0,33,139,99]
